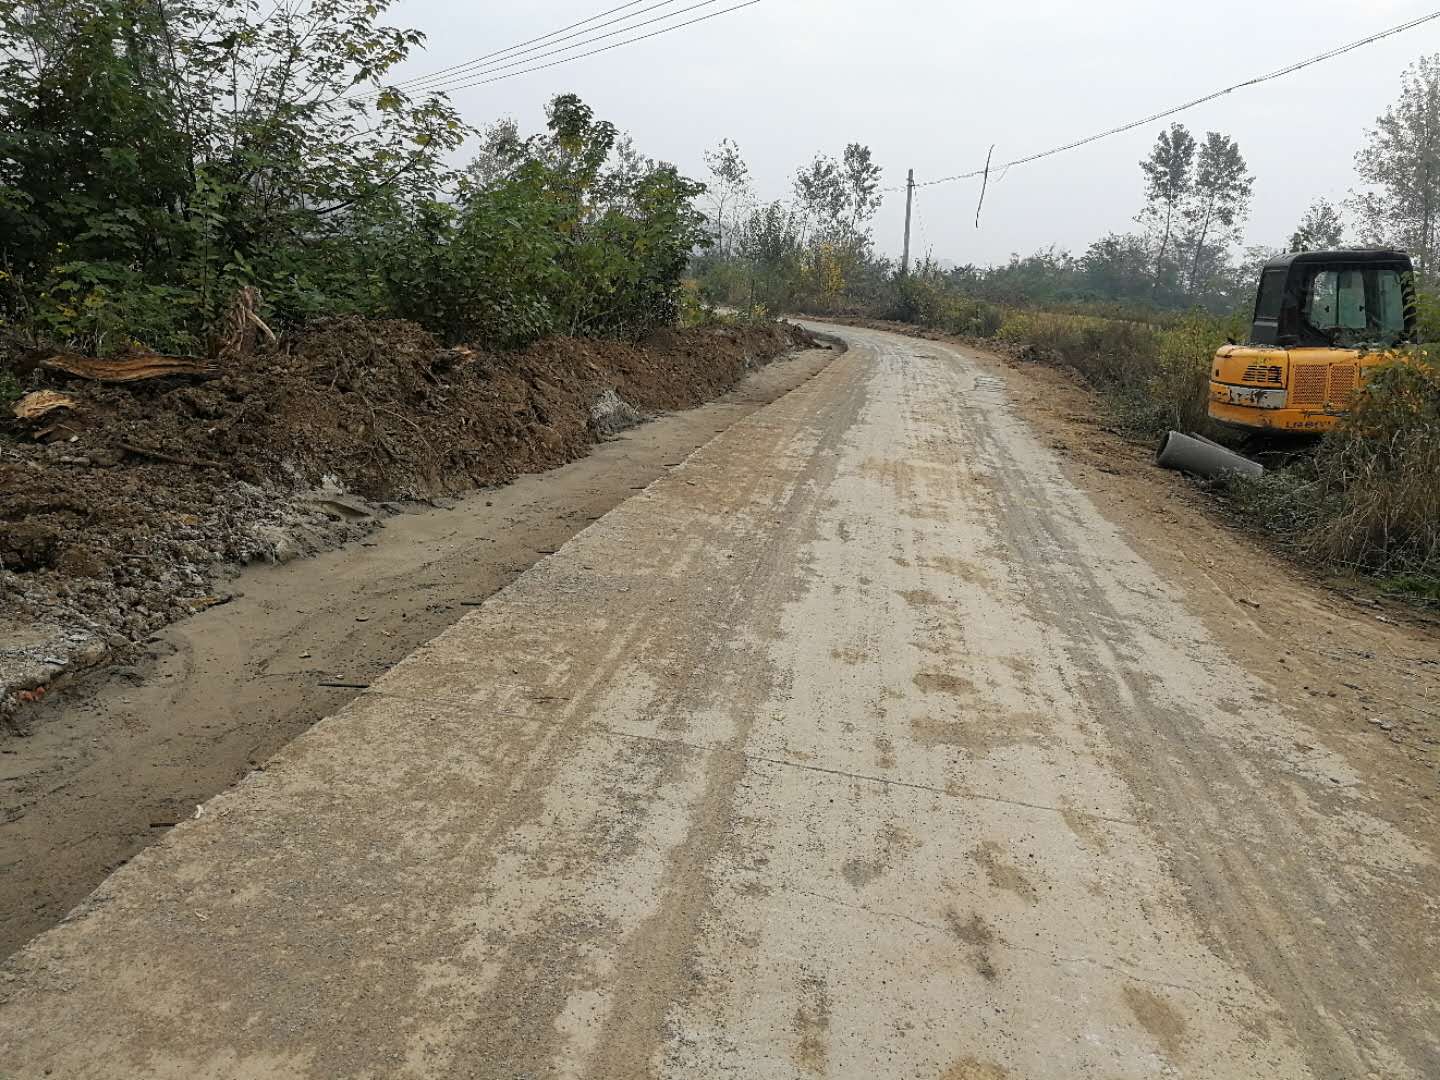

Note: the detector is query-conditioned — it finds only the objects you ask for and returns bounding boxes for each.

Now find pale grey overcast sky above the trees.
[387,0,1440,262]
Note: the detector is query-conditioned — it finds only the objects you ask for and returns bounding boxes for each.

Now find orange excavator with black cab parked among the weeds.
[1210,249,1416,433]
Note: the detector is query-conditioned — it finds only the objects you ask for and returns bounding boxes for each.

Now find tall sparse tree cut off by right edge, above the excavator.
[1354,55,1440,272]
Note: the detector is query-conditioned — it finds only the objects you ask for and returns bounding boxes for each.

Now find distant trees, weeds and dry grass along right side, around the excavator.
[694,56,1440,600]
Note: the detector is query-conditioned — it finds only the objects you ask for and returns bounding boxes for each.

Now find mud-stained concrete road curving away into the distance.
[0,328,1440,1080]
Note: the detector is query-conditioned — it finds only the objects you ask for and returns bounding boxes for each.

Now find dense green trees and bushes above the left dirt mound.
[0,0,704,354]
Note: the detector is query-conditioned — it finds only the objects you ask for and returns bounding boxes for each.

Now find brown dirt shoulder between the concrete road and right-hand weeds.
[952,346,1440,817]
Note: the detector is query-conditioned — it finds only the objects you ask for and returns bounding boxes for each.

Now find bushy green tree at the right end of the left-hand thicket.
[391,95,707,346]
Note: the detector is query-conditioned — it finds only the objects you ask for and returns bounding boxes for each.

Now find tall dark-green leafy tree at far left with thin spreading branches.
[0,0,465,348]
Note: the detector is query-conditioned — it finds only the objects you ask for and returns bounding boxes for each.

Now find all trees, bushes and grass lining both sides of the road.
[0,0,1440,601]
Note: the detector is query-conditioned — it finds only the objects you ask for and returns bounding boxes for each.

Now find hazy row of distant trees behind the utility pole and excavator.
[696,56,1440,321]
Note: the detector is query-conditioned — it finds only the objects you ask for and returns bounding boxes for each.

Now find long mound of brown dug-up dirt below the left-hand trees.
[0,318,809,723]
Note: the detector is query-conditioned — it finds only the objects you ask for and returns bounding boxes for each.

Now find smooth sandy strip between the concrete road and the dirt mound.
[0,350,834,956]
